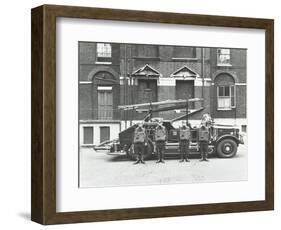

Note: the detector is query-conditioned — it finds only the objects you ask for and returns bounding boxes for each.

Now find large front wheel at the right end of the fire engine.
[217,139,237,158]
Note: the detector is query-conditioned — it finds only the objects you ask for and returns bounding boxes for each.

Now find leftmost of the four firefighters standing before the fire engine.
[134,124,146,164]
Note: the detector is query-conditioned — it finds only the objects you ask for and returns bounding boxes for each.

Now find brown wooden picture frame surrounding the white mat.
[31,5,274,224]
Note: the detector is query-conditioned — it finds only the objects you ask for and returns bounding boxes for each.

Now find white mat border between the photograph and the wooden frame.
[56,18,265,212]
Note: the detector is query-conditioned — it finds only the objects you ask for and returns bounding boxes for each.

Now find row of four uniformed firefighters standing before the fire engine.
[133,122,210,164]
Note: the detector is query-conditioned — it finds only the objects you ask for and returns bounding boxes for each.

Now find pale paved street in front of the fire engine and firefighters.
[80,141,247,187]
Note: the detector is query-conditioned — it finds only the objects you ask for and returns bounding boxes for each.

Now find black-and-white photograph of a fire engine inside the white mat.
[77,41,248,188]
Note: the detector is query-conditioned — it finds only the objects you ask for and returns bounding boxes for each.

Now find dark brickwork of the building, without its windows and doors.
[79,42,247,123]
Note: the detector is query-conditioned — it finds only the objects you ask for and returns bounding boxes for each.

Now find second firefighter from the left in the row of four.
[154,123,167,163]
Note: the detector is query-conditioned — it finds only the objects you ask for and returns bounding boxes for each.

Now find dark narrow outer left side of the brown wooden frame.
[31,7,44,223]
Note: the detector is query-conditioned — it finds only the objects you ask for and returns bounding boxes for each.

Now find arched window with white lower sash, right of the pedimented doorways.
[215,73,236,110]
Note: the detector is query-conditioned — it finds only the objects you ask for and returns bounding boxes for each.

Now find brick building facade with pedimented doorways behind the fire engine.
[79,42,247,146]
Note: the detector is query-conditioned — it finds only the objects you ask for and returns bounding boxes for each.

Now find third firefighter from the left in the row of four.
[179,122,190,162]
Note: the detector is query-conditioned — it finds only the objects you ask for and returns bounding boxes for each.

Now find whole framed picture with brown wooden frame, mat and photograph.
[31,5,274,224]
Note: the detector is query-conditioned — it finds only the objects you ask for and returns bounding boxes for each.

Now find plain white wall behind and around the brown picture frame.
[0,0,281,230]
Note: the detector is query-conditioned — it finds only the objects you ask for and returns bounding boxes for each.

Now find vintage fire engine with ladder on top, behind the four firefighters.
[95,98,244,159]
